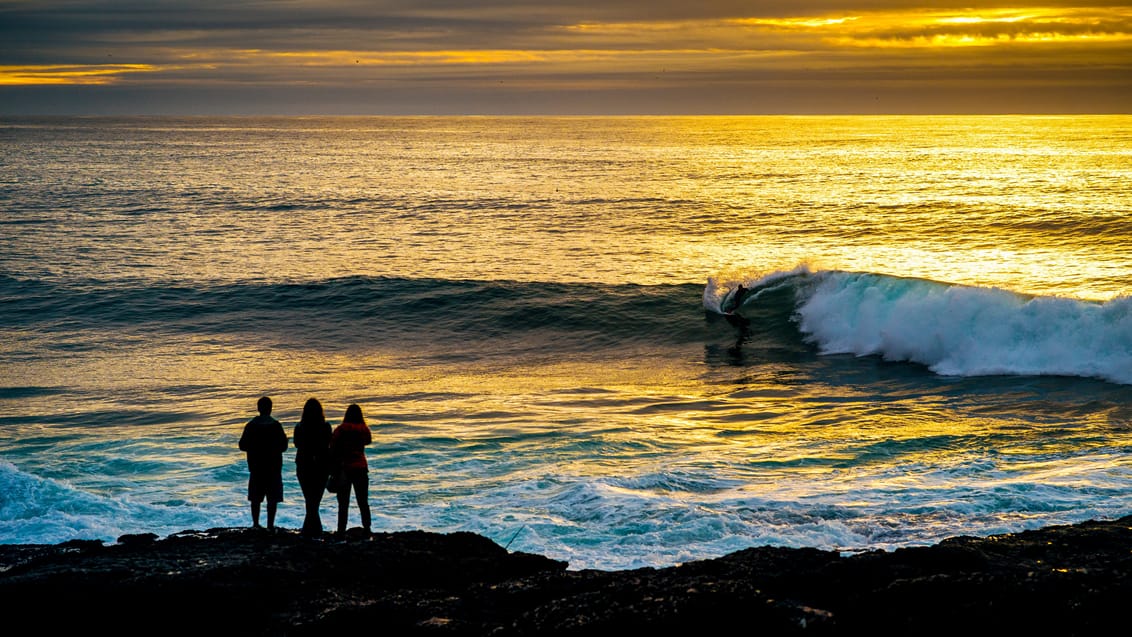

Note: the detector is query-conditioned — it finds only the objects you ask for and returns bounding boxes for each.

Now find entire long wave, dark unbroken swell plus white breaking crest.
[11,268,1132,385]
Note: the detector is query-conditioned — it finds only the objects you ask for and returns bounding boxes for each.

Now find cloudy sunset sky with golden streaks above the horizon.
[0,0,1132,115]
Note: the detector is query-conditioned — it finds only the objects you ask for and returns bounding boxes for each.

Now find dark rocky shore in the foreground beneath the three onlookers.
[0,516,1132,637]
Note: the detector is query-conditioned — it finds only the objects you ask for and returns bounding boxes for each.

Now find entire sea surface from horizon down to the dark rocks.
[0,115,1132,569]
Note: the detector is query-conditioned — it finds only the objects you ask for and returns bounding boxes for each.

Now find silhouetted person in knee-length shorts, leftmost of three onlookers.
[240,396,286,531]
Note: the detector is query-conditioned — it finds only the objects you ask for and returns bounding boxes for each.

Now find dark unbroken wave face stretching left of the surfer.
[0,276,709,351]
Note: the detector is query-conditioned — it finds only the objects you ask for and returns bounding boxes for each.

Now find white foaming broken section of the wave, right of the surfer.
[704,269,1132,385]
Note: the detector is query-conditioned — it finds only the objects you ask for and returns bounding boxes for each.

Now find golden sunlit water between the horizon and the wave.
[13,115,1132,299]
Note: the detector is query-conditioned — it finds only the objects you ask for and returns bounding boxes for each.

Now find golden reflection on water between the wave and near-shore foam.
[20,328,1118,479]
